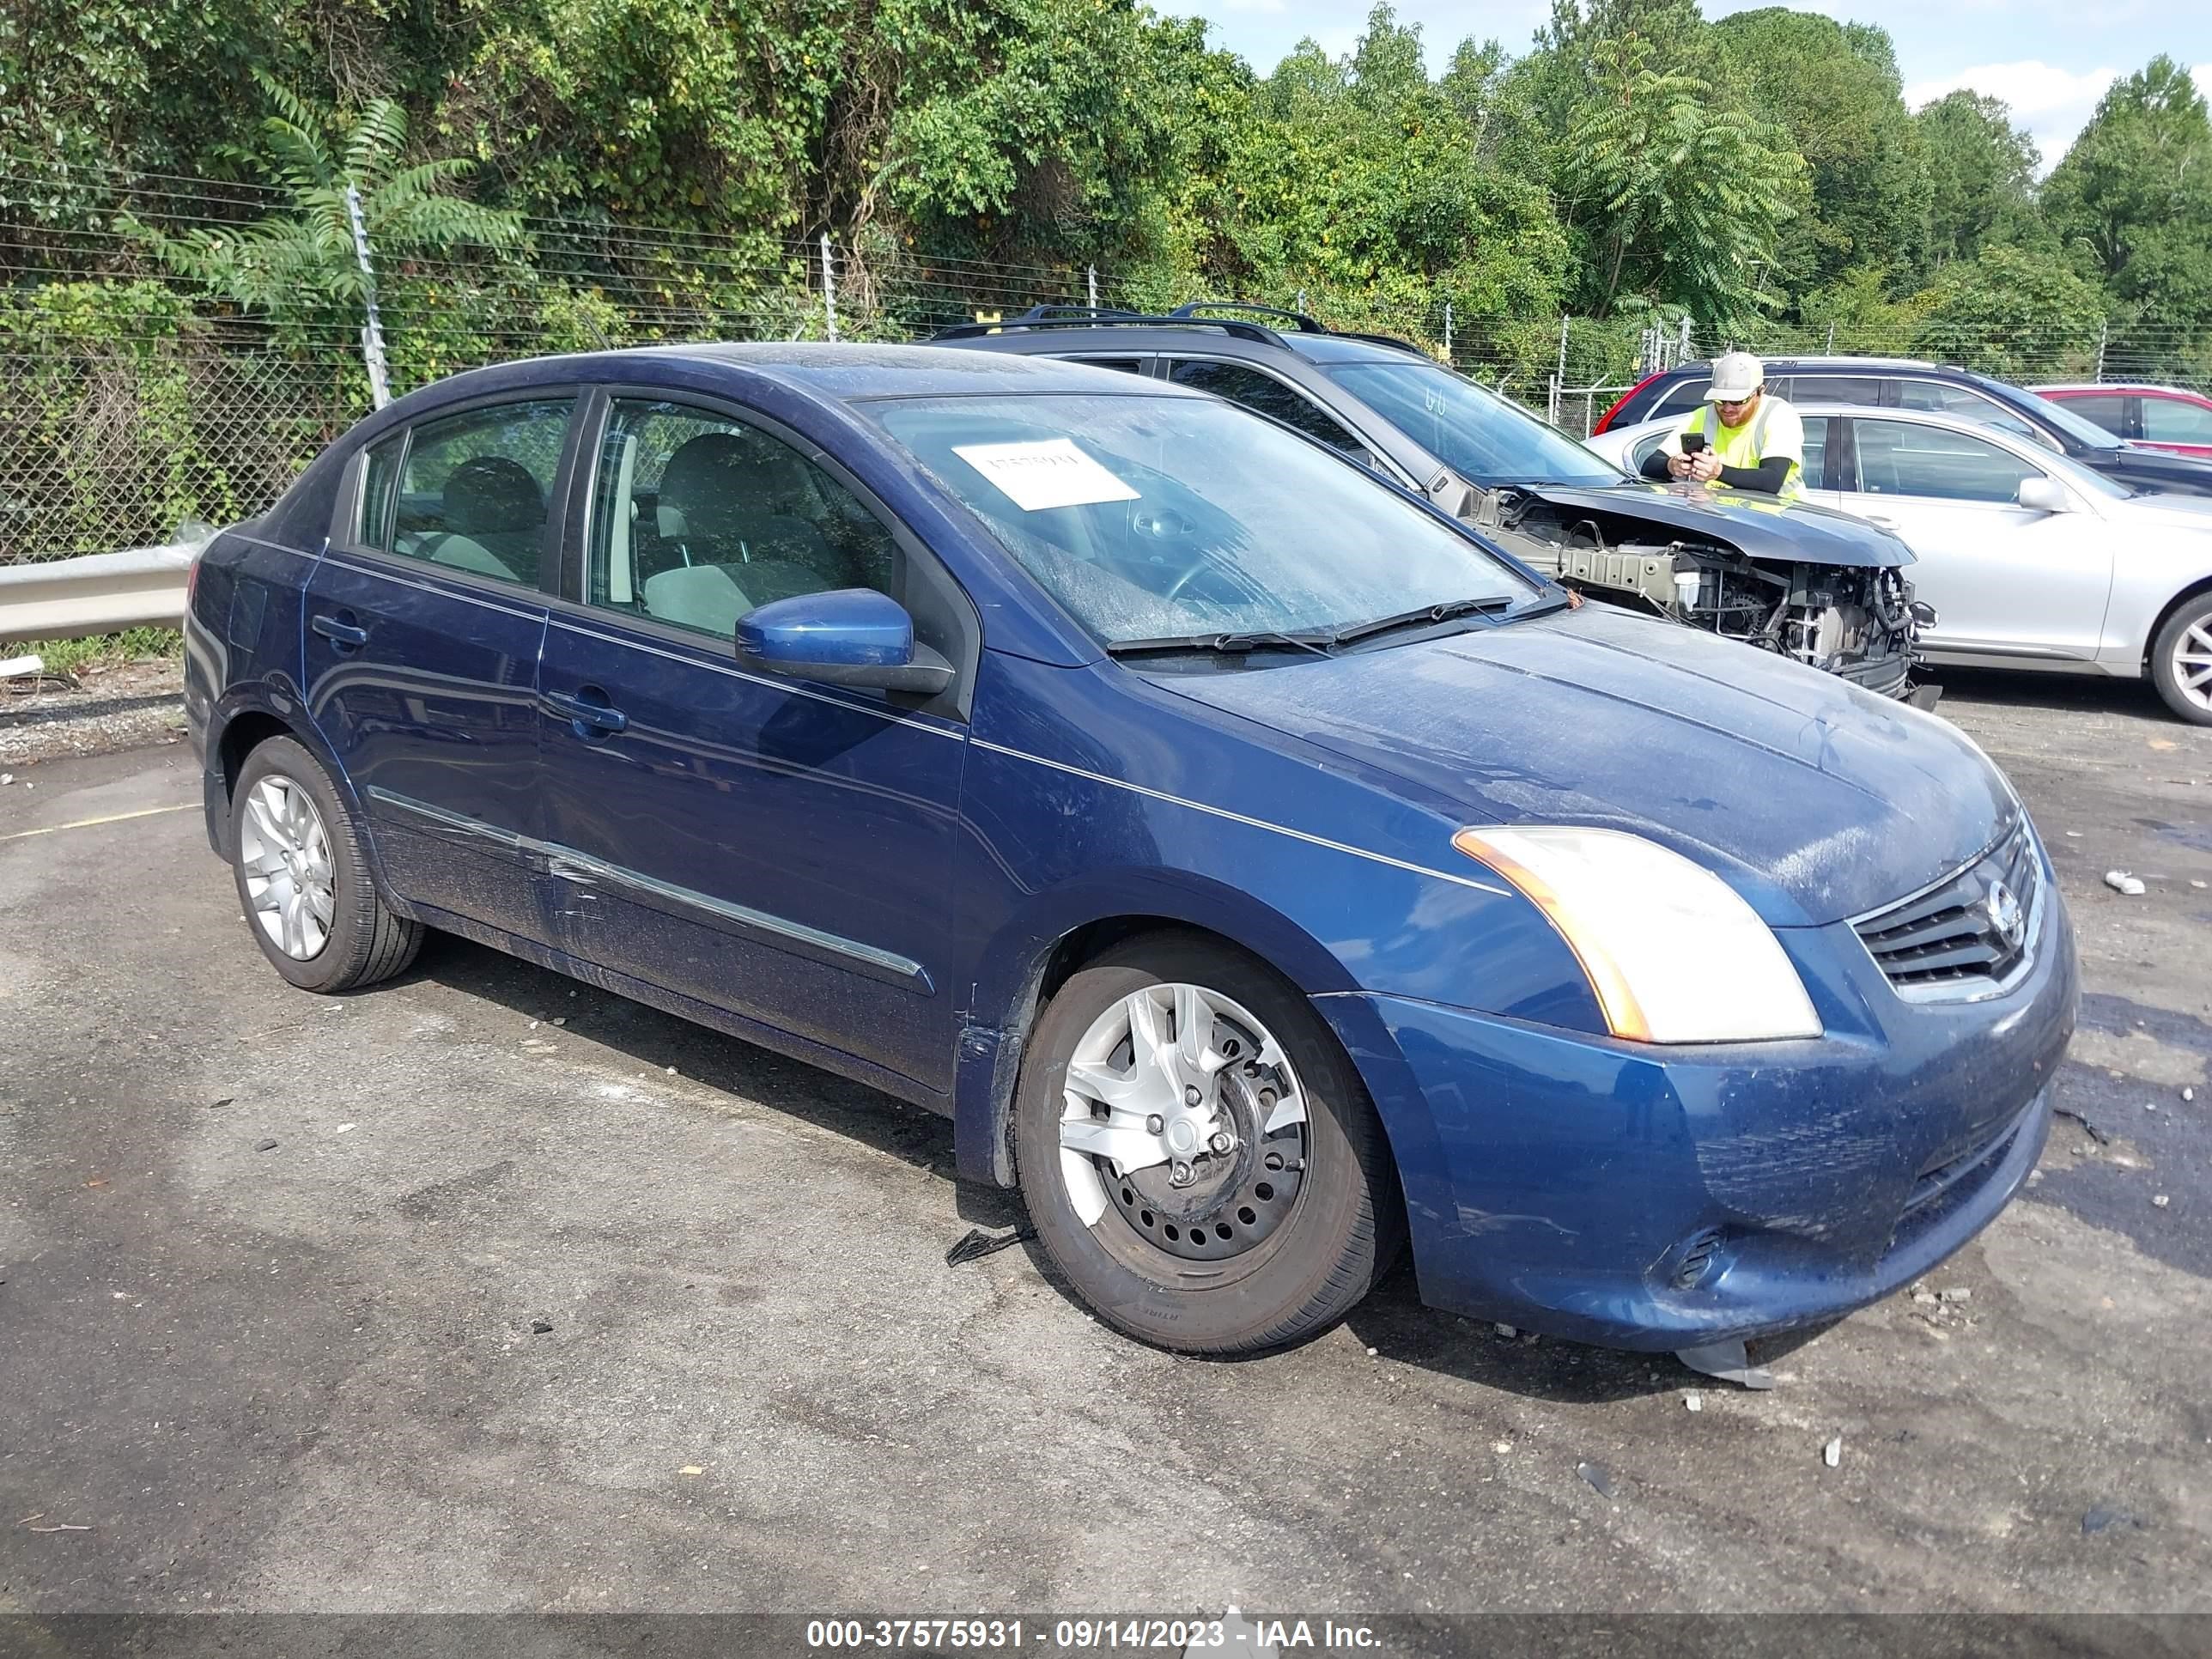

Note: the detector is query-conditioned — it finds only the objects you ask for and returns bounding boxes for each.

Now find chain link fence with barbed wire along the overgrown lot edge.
[0,157,2190,564]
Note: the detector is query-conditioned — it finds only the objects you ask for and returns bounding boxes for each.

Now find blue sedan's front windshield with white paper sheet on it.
[872,394,1540,646]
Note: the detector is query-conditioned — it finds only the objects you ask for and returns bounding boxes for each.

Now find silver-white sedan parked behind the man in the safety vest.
[1589,403,2212,726]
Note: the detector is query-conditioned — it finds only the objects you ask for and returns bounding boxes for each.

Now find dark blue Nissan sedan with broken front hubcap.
[185,345,2077,1354]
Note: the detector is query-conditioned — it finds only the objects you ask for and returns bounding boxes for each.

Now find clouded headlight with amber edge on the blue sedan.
[1451,825,1820,1042]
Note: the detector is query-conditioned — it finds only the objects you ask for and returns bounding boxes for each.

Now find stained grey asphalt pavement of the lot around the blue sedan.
[0,677,2212,1613]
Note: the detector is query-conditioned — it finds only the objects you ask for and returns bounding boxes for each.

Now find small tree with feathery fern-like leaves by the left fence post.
[126,76,522,325]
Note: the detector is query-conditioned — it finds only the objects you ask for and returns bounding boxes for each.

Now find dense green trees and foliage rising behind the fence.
[0,0,2212,383]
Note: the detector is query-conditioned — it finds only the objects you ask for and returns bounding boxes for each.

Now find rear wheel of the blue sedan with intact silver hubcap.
[230,737,422,991]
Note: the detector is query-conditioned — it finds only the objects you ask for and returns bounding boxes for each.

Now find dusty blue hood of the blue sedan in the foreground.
[1157,604,2020,925]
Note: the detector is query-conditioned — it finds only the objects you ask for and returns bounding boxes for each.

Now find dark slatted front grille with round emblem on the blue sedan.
[1851,817,2042,998]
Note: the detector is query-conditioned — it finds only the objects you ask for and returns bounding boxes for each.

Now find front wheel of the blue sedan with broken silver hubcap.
[1015,933,1402,1354]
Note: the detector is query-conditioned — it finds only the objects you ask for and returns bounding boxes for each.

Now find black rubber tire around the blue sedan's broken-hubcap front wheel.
[1013,933,1405,1356]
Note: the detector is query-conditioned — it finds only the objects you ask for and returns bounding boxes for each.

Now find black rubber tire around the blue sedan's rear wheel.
[230,737,422,995]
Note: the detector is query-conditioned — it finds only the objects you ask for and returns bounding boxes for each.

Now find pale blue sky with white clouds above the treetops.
[1185,0,2212,168]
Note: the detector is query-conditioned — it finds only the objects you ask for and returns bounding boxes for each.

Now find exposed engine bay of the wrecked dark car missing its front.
[1468,487,1933,696]
